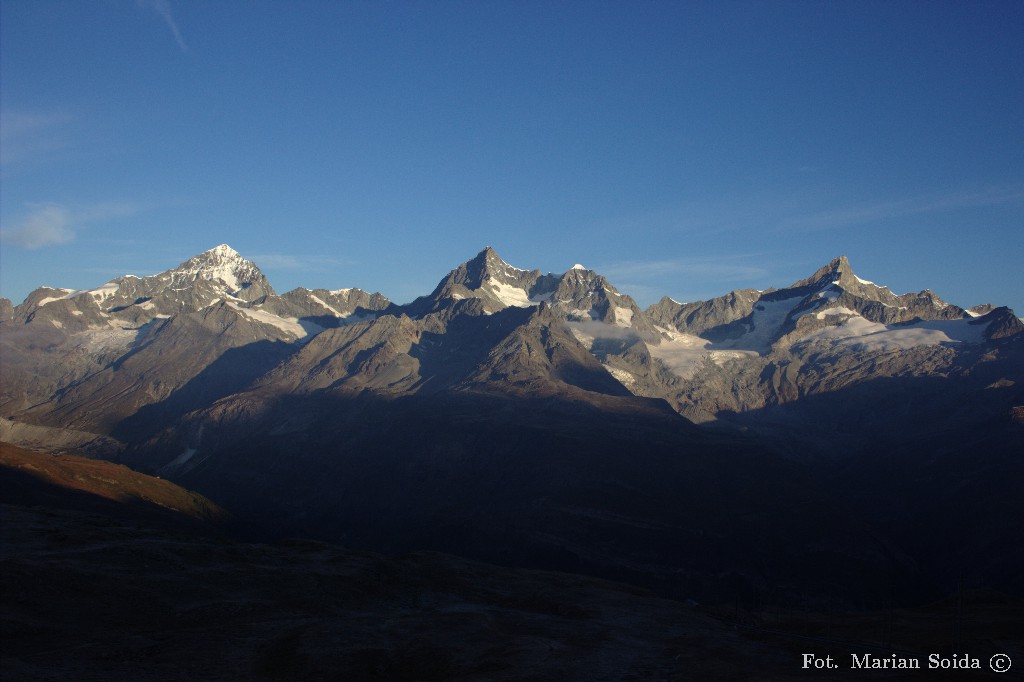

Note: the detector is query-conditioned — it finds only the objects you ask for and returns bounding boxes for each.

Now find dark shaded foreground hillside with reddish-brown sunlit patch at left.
[0,446,1024,680]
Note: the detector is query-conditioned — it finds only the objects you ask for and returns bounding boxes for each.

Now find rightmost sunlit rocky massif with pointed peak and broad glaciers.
[640,257,1024,430]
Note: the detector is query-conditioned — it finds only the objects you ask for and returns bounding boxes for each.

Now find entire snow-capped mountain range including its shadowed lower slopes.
[0,245,1024,606]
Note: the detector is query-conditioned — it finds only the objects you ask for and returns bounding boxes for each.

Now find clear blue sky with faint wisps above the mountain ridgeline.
[0,0,1024,314]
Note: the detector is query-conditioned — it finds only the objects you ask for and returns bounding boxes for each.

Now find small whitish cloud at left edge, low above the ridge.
[0,202,138,249]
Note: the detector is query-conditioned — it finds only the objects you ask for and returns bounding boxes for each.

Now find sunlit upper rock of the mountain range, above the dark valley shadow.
[0,245,1024,446]
